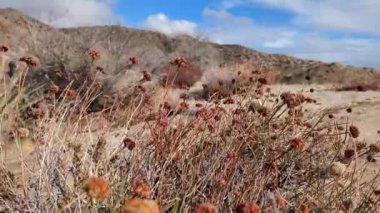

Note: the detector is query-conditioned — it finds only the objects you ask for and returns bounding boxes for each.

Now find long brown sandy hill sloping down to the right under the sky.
[0,9,380,87]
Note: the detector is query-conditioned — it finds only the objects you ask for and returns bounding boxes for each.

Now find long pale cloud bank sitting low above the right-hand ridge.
[199,9,380,67]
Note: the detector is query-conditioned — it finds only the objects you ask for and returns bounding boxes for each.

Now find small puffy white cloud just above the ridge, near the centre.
[144,13,197,36]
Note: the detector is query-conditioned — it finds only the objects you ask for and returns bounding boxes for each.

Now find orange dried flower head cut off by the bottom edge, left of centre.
[121,198,160,213]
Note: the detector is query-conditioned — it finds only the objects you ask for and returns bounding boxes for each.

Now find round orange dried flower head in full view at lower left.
[83,177,111,199]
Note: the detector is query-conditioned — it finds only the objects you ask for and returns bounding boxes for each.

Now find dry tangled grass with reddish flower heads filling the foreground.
[0,48,379,212]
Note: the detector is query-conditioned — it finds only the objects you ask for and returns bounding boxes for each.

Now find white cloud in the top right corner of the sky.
[222,0,380,35]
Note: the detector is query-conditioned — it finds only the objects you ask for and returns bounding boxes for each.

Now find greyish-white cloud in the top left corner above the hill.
[0,0,121,27]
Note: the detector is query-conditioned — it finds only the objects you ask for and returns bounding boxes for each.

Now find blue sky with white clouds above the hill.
[0,0,380,68]
